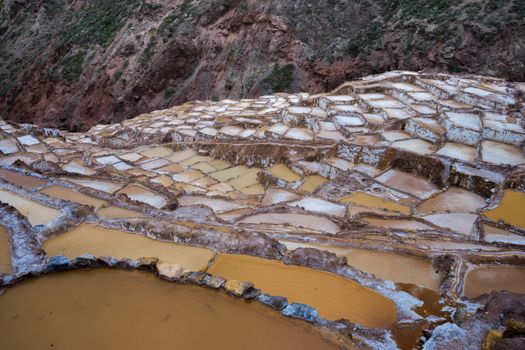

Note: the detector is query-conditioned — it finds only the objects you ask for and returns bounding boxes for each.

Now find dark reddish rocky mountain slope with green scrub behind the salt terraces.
[0,0,525,131]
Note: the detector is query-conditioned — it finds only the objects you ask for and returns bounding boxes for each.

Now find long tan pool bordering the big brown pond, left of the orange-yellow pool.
[44,224,213,271]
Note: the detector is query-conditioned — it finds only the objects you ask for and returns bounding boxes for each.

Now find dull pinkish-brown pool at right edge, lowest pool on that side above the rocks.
[463,266,525,298]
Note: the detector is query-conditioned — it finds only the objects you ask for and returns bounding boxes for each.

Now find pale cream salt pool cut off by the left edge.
[0,190,62,226]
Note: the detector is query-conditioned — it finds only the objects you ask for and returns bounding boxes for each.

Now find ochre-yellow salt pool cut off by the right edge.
[483,190,525,229]
